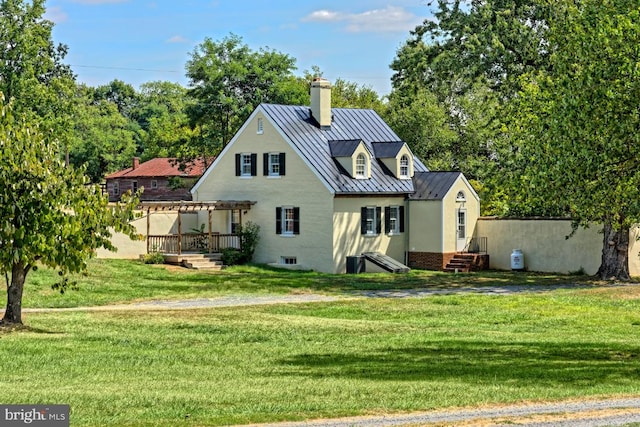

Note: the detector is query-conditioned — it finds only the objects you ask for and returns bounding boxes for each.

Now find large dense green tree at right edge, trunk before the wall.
[504,0,640,280]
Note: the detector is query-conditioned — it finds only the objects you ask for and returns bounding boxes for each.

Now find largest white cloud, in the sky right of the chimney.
[302,6,422,33]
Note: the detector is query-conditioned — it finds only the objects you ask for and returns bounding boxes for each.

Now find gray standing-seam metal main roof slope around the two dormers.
[261,104,428,194]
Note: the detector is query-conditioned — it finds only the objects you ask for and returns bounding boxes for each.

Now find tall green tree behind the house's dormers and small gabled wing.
[389,0,553,214]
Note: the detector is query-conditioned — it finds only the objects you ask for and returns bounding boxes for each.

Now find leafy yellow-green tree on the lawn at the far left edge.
[0,102,136,325]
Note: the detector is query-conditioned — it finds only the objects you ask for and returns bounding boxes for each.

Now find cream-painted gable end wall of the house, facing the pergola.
[193,111,333,271]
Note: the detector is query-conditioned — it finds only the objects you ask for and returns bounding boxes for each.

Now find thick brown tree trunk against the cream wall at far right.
[597,224,630,280]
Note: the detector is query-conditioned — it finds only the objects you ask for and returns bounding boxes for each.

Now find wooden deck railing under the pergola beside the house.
[147,233,240,254]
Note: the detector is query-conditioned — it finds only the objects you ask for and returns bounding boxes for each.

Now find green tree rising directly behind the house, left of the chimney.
[186,34,295,158]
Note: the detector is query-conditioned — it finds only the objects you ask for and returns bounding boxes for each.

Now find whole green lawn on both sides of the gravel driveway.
[0,261,640,426]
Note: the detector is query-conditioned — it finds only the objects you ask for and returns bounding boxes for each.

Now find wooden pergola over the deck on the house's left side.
[138,200,256,255]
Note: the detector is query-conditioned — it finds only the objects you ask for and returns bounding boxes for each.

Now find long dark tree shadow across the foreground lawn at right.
[279,341,640,387]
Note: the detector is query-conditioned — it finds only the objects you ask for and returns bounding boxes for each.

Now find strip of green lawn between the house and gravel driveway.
[13,260,597,307]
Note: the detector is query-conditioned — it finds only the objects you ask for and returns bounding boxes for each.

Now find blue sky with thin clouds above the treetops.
[45,0,430,95]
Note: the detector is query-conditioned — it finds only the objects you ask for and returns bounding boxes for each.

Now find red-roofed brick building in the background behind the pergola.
[106,157,206,202]
